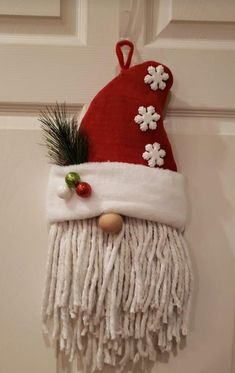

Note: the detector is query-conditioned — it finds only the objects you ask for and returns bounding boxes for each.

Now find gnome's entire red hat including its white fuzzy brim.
[48,40,186,229]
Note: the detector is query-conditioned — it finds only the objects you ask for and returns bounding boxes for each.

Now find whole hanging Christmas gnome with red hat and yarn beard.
[40,40,192,371]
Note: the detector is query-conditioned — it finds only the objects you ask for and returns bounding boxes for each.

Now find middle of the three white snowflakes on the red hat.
[134,106,160,131]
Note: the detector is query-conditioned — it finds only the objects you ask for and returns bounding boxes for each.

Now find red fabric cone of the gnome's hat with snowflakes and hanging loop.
[81,40,176,171]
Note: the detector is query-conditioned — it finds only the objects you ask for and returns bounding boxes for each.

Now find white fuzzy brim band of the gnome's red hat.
[47,162,187,229]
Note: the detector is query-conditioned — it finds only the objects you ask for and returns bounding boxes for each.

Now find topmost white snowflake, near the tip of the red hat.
[144,65,169,91]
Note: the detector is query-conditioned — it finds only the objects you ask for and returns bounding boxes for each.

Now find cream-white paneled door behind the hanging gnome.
[0,0,235,373]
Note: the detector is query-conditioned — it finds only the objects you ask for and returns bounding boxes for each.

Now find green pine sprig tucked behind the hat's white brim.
[39,103,88,166]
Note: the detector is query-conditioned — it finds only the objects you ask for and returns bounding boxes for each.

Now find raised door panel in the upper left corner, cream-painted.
[0,0,88,45]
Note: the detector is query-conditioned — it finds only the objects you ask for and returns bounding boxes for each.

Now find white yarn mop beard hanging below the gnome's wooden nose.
[42,217,192,371]
